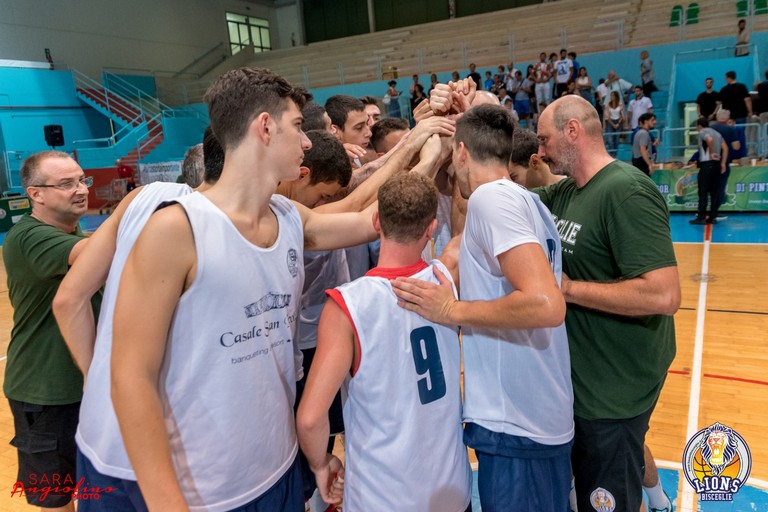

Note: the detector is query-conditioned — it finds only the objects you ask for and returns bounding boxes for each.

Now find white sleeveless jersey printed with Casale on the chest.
[160,193,304,512]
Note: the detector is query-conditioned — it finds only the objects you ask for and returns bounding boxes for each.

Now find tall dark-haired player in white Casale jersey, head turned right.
[111,68,390,511]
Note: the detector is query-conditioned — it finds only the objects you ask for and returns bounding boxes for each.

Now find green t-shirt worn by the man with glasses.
[3,215,101,405]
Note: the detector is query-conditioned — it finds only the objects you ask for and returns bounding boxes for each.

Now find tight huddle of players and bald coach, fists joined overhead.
[4,68,680,512]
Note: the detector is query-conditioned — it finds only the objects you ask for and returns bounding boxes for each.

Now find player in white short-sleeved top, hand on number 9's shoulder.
[393,105,574,512]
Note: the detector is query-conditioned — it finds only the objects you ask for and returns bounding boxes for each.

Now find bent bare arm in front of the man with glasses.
[53,187,141,375]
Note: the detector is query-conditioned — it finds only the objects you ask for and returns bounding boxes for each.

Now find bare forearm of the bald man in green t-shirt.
[562,267,681,316]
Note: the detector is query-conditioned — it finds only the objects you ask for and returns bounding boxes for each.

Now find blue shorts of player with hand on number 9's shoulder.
[464,423,573,512]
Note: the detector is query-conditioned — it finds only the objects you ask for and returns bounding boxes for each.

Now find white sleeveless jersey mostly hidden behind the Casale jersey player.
[75,182,192,480]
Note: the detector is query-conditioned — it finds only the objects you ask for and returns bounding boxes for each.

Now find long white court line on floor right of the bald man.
[678,229,711,512]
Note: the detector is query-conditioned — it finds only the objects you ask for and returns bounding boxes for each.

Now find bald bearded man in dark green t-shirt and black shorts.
[537,96,680,510]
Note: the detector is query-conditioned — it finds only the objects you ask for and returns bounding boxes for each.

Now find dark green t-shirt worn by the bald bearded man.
[536,161,677,419]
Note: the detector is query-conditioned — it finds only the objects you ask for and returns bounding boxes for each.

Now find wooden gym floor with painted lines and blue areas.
[0,210,768,512]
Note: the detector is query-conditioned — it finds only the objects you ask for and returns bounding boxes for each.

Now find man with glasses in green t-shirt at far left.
[3,151,101,511]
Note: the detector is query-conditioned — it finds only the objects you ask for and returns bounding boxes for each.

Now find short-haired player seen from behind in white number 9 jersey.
[297,173,471,512]
